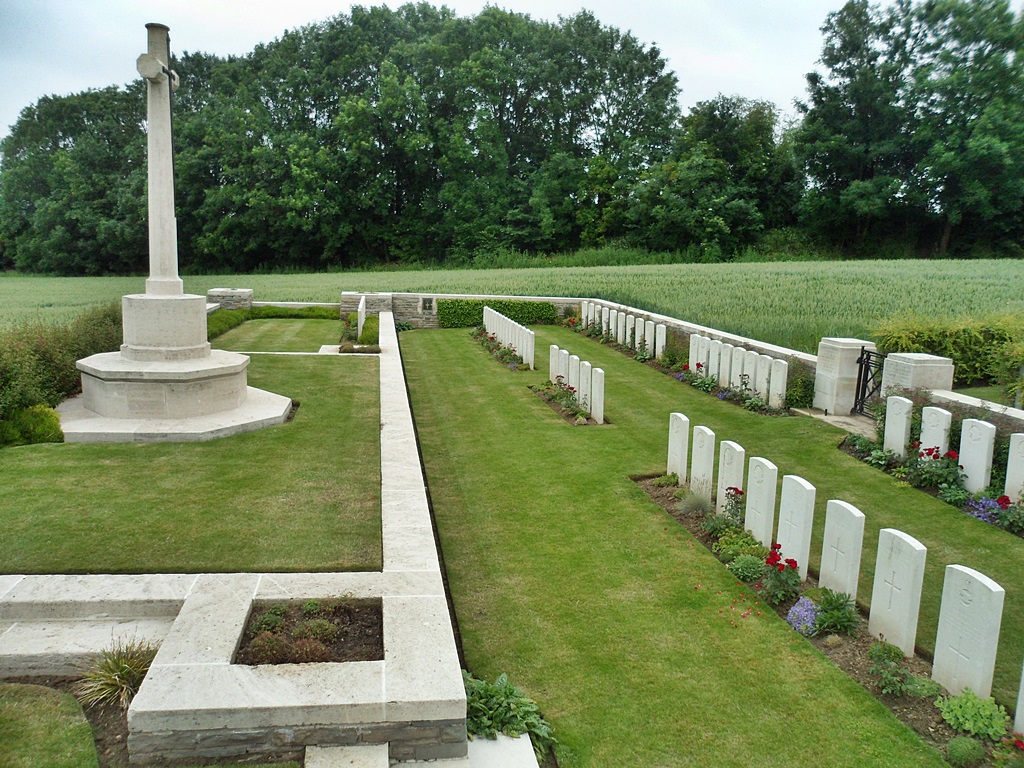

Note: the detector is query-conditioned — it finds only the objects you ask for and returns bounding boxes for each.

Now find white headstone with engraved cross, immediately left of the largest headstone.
[867,528,928,658]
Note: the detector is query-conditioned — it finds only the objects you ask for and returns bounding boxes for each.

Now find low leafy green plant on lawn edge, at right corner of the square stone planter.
[462,671,557,758]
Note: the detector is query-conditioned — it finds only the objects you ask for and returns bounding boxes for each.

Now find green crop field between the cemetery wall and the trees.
[0,260,1024,352]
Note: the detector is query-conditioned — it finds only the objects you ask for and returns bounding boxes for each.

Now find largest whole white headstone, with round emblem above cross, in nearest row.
[932,565,1006,698]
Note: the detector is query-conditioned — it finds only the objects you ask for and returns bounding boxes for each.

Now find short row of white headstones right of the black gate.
[882,395,1024,502]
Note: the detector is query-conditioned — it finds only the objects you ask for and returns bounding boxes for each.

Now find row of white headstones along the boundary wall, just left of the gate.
[688,334,790,409]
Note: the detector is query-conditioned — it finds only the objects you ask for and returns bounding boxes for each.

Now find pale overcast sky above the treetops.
[0,0,1024,144]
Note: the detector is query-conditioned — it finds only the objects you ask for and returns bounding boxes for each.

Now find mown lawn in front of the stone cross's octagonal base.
[0,355,381,573]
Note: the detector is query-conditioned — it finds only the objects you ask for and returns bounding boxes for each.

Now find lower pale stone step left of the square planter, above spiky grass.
[0,617,174,677]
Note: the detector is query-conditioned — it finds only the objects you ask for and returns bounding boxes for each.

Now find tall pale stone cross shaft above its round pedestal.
[135,24,183,296]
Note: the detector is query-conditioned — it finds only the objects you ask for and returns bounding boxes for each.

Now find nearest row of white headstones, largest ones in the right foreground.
[667,413,1024,731]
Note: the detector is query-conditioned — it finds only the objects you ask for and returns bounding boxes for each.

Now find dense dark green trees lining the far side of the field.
[0,0,1024,274]
